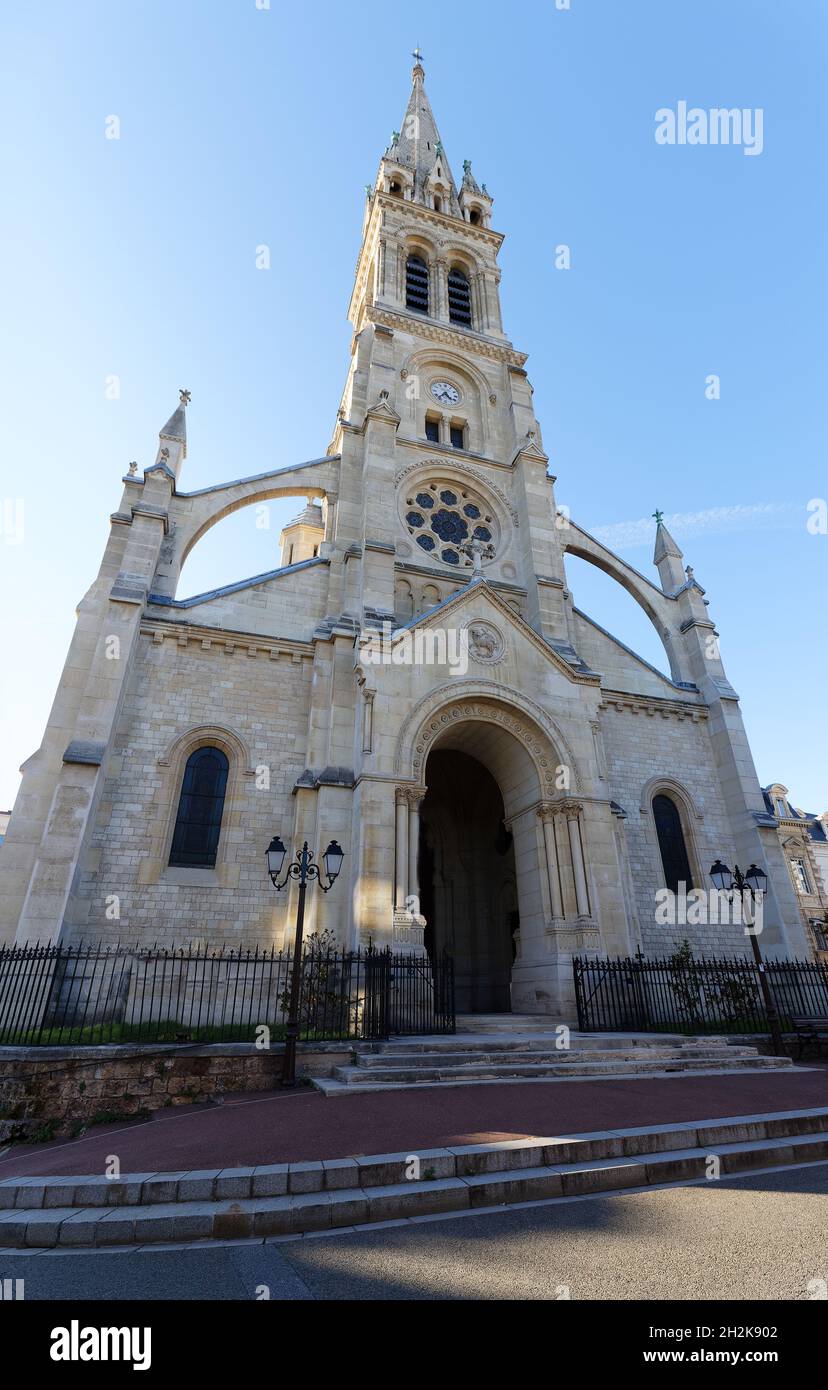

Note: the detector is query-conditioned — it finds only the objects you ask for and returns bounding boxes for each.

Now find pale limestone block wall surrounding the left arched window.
[75,635,311,948]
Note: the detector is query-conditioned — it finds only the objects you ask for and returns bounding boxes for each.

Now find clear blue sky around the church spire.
[0,0,828,812]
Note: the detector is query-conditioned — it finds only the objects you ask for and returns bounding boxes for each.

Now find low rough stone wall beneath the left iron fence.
[0,1043,352,1141]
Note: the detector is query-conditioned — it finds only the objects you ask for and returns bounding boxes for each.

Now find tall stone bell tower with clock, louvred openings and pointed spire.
[329,51,568,642]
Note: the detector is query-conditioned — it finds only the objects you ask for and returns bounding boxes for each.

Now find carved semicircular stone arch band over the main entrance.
[395,681,581,796]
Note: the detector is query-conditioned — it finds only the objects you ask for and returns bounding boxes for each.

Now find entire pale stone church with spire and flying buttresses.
[0,63,807,1017]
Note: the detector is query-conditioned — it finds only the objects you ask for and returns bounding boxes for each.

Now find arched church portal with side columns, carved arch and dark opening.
[395,695,597,1019]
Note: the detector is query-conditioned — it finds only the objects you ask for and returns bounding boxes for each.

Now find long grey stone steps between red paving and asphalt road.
[0,1108,828,1250]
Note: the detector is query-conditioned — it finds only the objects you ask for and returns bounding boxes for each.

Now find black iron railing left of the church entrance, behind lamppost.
[0,944,454,1045]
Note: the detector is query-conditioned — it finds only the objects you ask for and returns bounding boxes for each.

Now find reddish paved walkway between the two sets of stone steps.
[0,1068,828,1179]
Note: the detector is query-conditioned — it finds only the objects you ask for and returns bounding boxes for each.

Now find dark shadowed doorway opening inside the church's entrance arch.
[418,748,520,1013]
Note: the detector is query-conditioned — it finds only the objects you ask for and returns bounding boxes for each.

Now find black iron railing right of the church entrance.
[572,954,828,1033]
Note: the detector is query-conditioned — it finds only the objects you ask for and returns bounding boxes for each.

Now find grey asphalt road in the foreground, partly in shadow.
[6,1163,828,1301]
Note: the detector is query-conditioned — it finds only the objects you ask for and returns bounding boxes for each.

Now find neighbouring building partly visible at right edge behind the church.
[763,783,828,959]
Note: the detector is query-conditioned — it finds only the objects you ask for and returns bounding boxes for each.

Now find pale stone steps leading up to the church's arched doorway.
[314,1013,793,1095]
